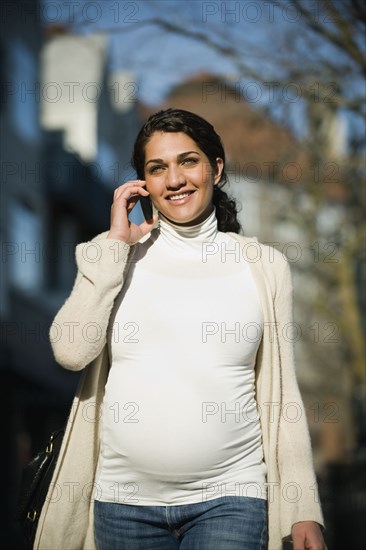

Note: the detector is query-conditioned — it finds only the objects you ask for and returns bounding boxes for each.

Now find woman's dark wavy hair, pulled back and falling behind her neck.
[131,109,241,233]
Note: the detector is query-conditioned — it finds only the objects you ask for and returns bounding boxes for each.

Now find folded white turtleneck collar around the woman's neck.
[157,209,218,254]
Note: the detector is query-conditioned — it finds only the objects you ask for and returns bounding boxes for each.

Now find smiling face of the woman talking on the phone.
[144,132,224,225]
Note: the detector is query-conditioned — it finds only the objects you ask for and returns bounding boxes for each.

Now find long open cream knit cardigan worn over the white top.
[34,233,323,550]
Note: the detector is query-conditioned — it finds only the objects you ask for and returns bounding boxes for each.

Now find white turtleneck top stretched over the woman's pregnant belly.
[95,212,266,506]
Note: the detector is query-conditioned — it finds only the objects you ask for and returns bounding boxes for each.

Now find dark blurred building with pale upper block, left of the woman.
[0,0,138,550]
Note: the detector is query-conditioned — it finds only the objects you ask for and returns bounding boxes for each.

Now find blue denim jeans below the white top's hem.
[94,496,267,550]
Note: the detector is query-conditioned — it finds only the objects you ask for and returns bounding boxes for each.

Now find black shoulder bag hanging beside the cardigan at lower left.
[16,429,65,548]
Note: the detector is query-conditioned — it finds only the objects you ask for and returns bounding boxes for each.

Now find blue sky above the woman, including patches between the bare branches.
[41,0,365,144]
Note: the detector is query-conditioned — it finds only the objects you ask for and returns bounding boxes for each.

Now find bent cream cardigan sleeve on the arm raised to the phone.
[49,233,133,370]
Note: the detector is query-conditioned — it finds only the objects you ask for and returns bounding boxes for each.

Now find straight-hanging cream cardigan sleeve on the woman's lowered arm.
[274,255,324,533]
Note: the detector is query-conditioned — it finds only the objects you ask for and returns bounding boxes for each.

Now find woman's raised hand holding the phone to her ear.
[107,180,158,244]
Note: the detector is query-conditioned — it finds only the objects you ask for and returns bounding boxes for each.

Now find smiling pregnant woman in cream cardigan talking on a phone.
[35,109,326,550]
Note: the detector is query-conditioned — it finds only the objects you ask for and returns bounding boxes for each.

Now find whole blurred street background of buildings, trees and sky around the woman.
[0,0,366,550]
